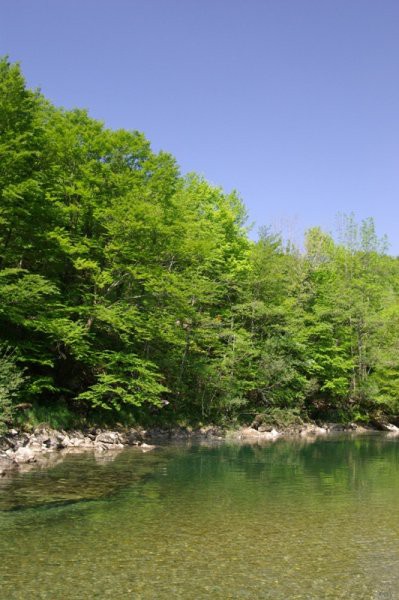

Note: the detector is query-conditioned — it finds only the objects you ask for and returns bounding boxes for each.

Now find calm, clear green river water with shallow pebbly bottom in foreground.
[0,435,399,600]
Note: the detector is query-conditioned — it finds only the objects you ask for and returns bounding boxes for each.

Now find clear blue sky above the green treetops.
[0,0,399,254]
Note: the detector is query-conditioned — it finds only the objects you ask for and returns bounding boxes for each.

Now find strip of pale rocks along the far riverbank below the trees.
[0,423,399,477]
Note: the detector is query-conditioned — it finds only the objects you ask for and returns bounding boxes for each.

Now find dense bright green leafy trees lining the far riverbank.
[0,59,399,423]
